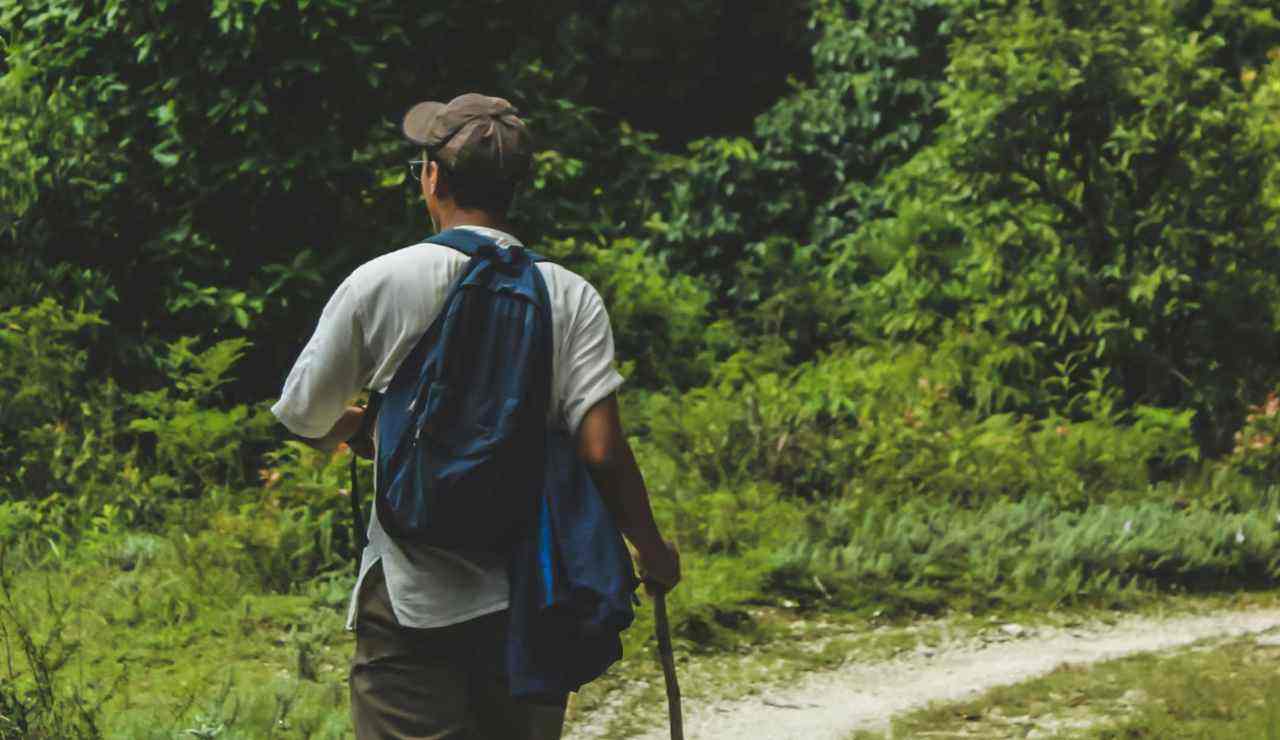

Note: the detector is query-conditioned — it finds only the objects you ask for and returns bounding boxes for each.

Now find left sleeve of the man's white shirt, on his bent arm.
[271,275,372,439]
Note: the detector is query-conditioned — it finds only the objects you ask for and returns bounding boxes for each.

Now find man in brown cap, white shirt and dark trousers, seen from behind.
[271,93,680,740]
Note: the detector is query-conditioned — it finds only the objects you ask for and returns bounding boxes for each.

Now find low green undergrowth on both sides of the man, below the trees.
[0,273,1280,737]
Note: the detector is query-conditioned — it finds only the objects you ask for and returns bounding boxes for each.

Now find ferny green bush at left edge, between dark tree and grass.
[0,300,290,543]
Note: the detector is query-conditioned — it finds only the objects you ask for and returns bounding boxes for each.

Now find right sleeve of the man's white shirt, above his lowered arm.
[559,280,622,434]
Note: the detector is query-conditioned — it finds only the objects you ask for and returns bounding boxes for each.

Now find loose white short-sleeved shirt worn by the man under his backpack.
[271,227,622,629]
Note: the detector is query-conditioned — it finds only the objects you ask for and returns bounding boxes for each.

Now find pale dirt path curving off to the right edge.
[575,609,1280,740]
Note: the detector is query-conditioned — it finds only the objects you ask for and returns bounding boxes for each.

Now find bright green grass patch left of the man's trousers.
[0,538,352,739]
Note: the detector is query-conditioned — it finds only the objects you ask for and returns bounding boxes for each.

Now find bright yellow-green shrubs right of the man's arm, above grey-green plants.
[628,346,1197,512]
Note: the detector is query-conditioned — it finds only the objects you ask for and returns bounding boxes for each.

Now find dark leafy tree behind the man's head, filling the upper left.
[0,0,794,397]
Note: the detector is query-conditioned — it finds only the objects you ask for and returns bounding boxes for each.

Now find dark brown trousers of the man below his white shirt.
[351,563,564,740]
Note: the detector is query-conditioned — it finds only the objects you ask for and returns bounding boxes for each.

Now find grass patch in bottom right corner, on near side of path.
[875,624,1280,740]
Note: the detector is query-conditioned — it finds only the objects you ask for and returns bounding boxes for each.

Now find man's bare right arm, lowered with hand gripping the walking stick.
[577,393,680,590]
